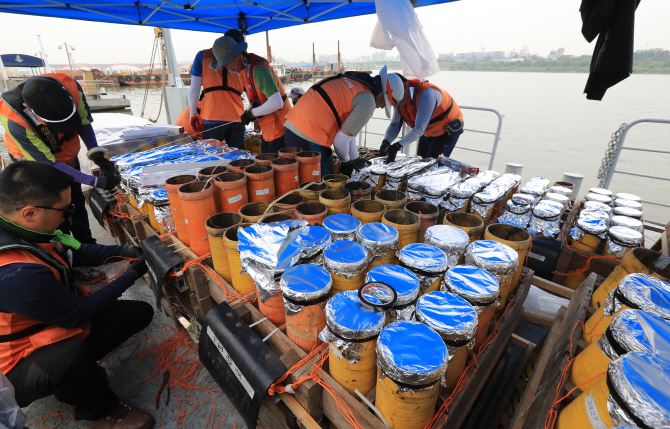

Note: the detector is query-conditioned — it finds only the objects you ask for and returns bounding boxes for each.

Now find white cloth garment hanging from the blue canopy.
[370,0,440,79]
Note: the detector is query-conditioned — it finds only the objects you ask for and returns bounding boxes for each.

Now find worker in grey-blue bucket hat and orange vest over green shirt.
[212,30,291,153]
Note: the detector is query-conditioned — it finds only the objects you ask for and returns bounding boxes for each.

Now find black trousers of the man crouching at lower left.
[6,301,154,420]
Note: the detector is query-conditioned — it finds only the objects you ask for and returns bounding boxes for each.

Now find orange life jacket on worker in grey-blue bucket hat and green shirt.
[246,54,291,142]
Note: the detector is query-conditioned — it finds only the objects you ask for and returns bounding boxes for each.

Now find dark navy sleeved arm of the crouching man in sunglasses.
[0,264,138,329]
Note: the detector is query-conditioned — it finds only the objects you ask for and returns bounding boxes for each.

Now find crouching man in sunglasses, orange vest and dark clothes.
[0,161,153,429]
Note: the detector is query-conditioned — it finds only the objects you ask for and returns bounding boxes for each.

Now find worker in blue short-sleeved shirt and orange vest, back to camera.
[188,30,244,149]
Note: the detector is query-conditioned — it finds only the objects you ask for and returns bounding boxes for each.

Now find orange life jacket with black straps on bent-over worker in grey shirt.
[286,72,382,146]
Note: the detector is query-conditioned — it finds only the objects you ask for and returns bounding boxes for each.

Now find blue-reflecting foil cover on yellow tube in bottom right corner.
[607,352,670,428]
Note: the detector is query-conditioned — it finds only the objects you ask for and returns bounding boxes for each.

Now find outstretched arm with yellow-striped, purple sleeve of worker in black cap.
[3,116,98,186]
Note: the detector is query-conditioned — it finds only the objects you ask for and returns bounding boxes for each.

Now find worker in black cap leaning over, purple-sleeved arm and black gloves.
[0,73,121,244]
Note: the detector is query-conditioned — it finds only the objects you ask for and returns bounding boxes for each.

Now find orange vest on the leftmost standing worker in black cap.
[0,73,81,164]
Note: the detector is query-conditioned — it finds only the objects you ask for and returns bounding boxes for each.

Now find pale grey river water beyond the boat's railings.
[117,71,670,224]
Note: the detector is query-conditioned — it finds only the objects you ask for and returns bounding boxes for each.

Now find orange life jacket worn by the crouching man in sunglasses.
[0,230,91,374]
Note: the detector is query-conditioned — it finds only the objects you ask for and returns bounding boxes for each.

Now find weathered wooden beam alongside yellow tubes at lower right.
[510,273,604,429]
